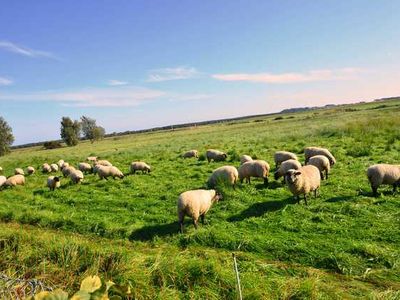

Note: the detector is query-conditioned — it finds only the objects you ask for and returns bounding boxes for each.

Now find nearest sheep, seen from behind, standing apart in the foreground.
[177,190,222,233]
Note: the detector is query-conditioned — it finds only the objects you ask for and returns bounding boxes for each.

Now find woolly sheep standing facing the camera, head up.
[285,165,321,205]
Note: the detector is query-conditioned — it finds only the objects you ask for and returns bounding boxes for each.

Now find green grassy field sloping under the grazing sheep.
[0,100,400,299]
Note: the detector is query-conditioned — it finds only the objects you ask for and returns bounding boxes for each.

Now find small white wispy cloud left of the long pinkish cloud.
[147,66,200,82]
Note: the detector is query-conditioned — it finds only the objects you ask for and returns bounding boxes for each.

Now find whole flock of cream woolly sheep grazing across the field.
[0,147,400,232]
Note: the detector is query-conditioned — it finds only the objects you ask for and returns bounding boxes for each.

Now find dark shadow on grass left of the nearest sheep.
[129,222,179,241]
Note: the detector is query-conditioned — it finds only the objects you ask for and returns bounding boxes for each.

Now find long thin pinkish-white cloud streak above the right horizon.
[211,68,362,83]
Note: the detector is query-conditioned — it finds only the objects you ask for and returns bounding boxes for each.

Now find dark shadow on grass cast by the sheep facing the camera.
[227,197,297,222]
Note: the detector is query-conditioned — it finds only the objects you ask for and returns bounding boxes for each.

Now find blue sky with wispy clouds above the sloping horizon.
[0,0,400,145]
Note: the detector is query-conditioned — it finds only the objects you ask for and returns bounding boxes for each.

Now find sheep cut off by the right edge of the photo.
[367,164,400,197]
